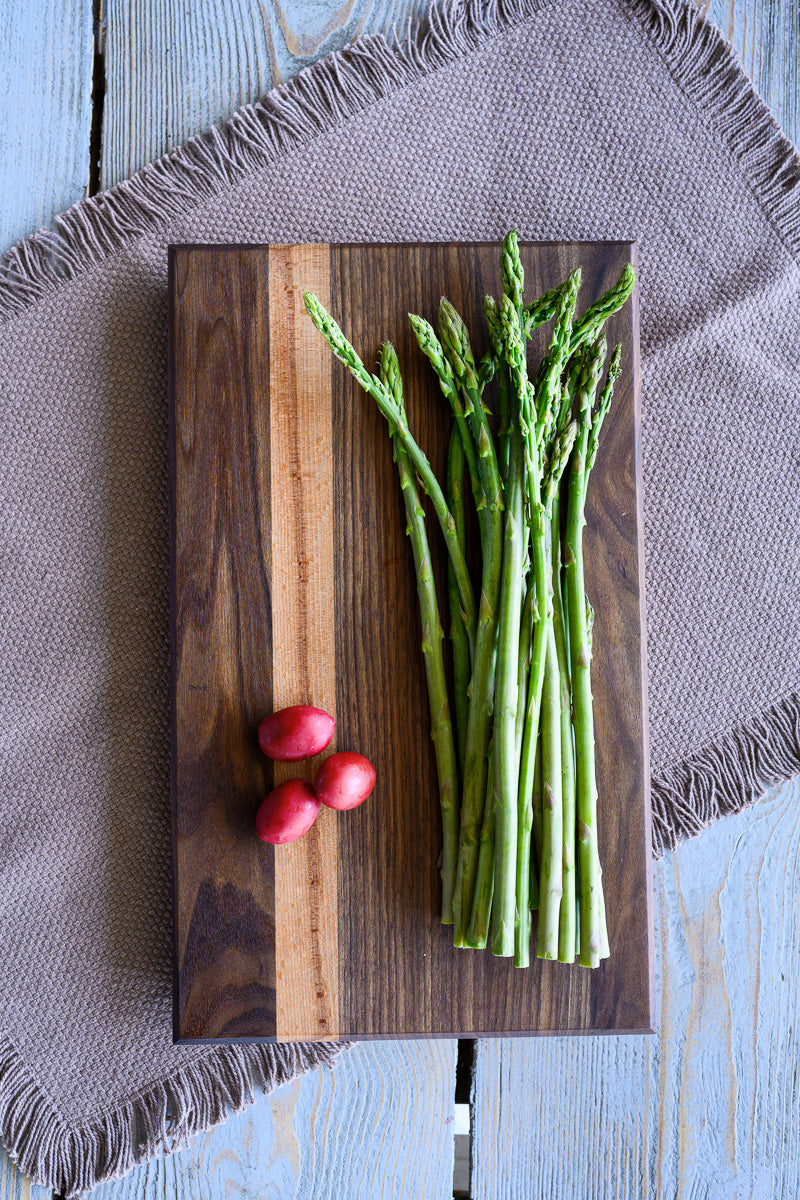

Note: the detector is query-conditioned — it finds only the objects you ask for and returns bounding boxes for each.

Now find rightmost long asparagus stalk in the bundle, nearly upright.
[564,342,619,967]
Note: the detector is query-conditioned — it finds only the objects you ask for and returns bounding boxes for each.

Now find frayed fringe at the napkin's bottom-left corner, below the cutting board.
[0,1038,341,1196]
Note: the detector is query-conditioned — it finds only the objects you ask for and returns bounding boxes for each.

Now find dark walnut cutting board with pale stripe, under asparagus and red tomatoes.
[169,236,652,1042]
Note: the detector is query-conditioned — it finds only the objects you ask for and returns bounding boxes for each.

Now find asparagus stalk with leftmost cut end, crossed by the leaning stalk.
[380,342,458,925]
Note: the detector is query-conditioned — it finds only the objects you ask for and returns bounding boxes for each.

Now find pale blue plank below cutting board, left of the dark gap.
[86,1040,456,1200]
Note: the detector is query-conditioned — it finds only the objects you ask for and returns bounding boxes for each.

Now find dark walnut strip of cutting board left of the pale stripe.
[169,248,276,1038]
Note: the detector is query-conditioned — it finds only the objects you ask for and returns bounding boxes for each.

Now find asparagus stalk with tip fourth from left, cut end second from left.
[439,299,503,946]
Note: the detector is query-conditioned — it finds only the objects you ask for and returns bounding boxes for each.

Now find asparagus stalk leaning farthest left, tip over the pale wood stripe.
[303,292,477,654]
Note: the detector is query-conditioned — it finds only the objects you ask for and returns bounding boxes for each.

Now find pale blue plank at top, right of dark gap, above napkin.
[103,0,427,187]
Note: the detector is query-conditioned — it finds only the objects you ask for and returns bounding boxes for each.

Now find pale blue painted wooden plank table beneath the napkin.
[0,0,800,1200]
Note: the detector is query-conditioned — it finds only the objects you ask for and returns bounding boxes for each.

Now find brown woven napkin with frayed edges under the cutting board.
[0,0,800,1192]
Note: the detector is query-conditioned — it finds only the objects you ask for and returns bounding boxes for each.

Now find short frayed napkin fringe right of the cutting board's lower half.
[650,694,800,858]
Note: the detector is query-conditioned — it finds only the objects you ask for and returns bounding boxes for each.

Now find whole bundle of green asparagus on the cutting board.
[305,232,634,967]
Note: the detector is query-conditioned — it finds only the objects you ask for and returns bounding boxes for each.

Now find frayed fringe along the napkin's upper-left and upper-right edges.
[0,0,800,319]
